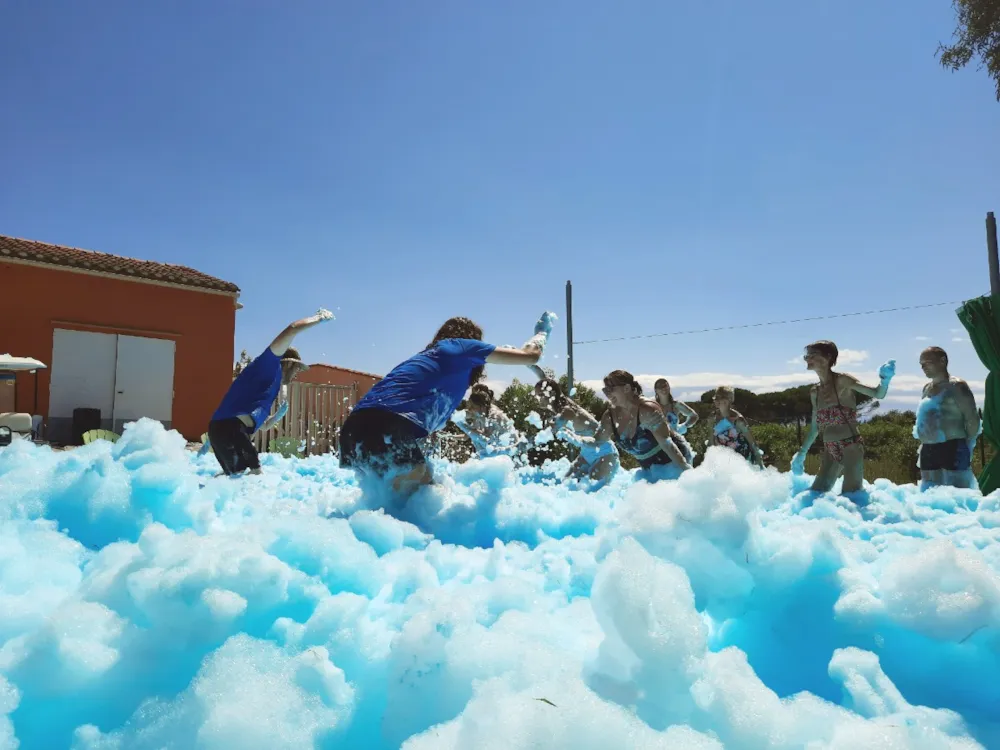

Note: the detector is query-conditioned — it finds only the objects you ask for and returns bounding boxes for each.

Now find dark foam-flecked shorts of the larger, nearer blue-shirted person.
[340,409,427,476]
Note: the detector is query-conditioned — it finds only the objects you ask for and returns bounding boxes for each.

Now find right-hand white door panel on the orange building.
[114,334,175,432]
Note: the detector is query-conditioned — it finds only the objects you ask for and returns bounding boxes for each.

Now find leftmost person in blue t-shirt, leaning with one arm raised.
[202,310,333,476]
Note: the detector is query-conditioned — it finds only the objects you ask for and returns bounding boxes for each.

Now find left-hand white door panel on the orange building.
[49,328,118,422]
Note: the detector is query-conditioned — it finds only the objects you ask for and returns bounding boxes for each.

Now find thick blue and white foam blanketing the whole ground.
[0,428,1000,750]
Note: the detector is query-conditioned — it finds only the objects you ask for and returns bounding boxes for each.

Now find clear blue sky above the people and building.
[0,0,1000,412]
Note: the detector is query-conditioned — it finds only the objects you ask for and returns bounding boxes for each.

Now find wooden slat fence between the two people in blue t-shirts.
[253,381,358,456]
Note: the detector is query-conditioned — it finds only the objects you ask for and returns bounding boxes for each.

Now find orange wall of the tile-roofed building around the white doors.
[0,261,236,440]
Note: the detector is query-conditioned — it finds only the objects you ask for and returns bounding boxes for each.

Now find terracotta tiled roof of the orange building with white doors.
[0,235,240,294]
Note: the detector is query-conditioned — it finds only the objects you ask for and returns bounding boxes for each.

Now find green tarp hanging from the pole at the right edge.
[956,295,1000,495]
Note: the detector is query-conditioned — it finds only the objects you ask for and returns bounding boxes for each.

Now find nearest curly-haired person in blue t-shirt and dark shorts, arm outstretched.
[340,313,555,494]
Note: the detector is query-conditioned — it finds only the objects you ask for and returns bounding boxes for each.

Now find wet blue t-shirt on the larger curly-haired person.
[354,339,496,435]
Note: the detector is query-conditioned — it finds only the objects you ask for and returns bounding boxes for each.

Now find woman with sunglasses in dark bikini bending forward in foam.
[581,370,691,478]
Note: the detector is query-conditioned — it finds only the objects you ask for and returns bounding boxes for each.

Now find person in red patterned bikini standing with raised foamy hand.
[792,341,896,494]
